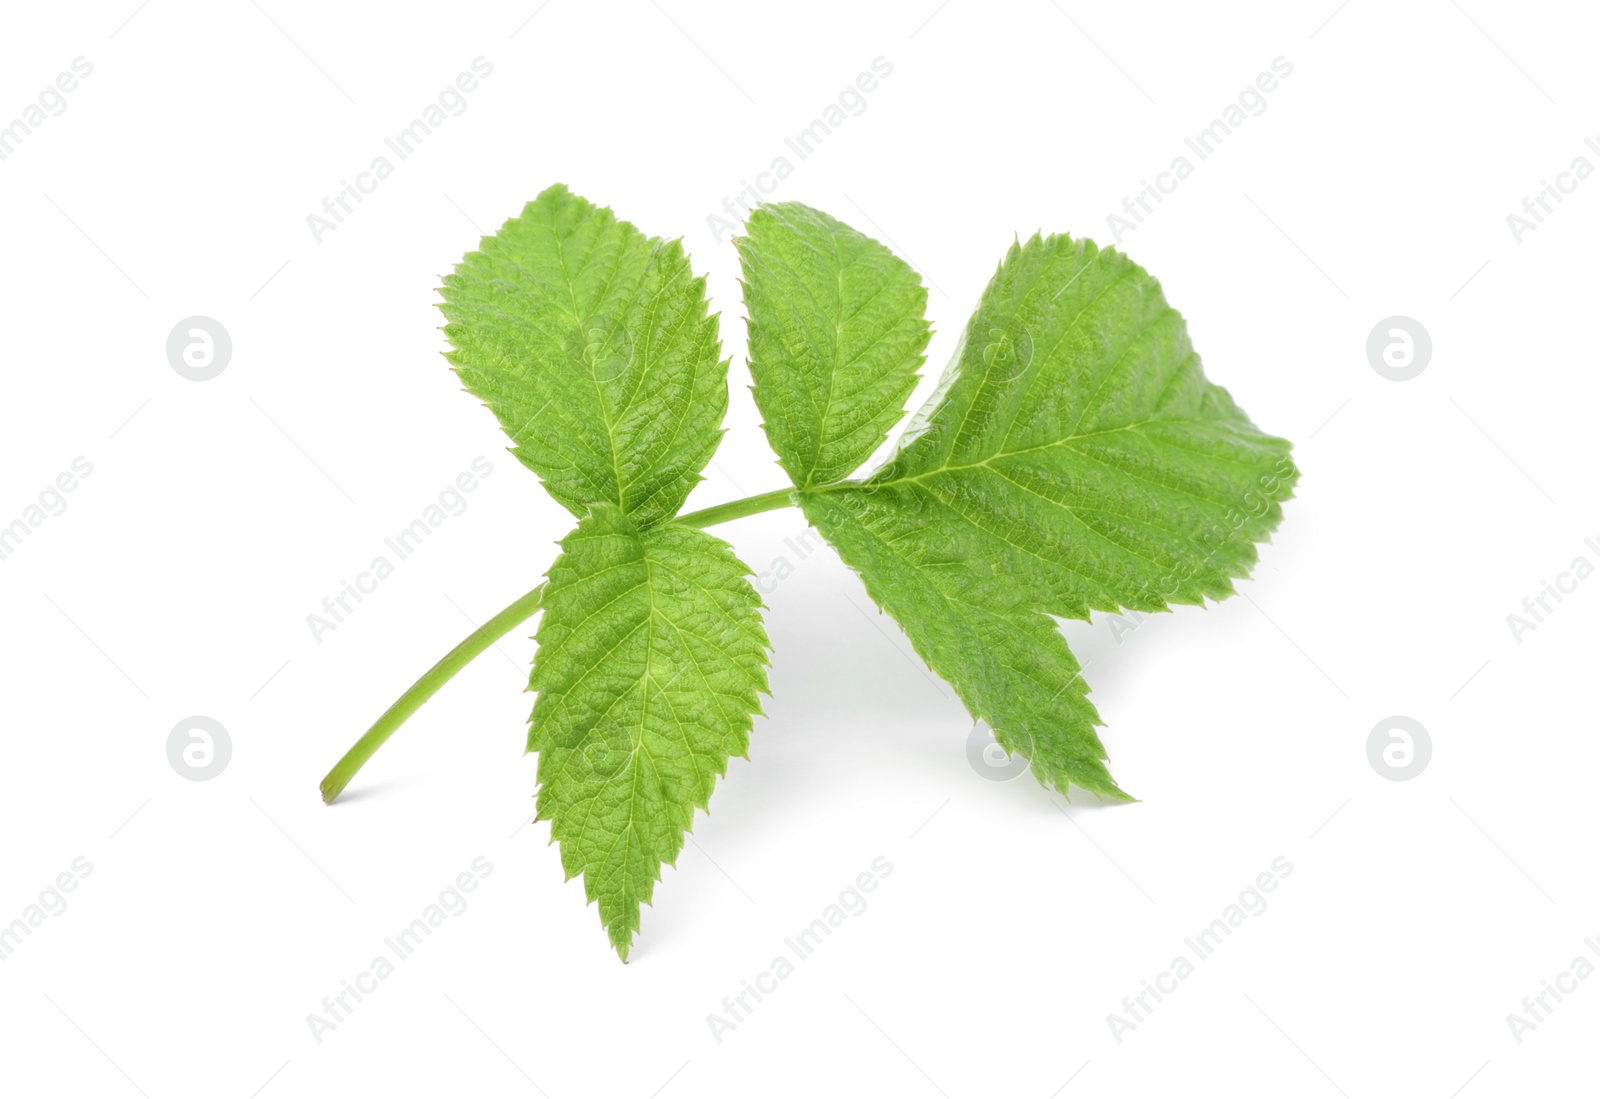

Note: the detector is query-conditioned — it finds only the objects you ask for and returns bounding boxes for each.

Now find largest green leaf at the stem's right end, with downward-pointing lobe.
[800,237,1298,797]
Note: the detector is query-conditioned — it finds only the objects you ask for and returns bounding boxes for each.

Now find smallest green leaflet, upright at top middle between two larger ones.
[736,202,928,488]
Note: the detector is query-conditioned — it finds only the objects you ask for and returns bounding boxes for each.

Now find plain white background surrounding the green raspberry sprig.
[0,0,1600,1099]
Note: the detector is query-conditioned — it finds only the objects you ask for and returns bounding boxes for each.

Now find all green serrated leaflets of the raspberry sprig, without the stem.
[442,186,1298,960]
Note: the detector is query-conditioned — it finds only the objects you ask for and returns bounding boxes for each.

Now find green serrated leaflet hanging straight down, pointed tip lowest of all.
[528,506,770,960]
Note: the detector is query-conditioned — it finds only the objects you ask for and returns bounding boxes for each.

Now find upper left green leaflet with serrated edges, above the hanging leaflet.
[440,184,728,526]
